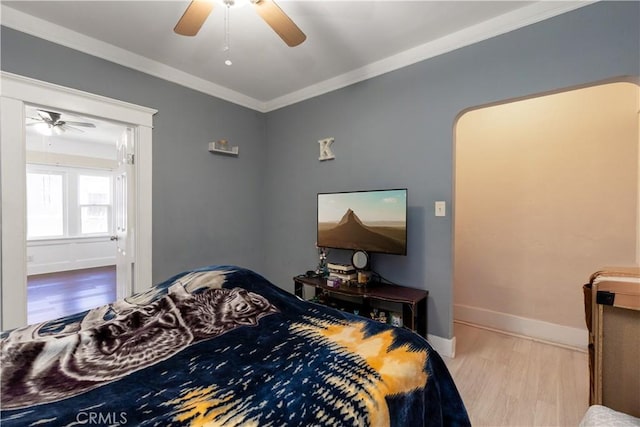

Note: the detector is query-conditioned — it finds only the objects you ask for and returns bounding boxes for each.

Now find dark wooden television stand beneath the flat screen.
[293,274,429,338]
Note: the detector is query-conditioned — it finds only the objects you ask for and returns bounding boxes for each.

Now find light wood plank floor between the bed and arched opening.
[444,323,589,427]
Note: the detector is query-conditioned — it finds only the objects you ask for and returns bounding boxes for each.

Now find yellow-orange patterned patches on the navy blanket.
[167,317,428,426]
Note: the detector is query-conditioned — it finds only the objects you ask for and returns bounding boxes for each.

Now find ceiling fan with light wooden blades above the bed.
[173,0,307,47]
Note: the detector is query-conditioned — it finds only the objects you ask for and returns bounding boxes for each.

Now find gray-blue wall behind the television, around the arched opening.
[265,2,640,337]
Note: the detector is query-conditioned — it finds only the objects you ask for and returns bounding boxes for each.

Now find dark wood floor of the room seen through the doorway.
[27,265,117,324]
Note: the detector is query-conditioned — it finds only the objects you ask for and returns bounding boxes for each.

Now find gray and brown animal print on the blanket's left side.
[1,283,277,409]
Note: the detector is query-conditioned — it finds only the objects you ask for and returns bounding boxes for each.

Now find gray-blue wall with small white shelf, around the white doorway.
[1,27,266,282]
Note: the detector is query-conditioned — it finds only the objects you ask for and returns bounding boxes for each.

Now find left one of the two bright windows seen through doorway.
[27,172,65,239]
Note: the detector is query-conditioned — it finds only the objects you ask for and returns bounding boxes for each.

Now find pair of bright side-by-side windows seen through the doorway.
[27,165,113,240]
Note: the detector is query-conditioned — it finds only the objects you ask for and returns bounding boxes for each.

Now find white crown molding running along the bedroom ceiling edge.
[1,1,594,113]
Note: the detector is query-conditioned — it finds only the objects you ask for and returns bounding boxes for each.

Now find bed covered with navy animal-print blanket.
[0,266,470,426]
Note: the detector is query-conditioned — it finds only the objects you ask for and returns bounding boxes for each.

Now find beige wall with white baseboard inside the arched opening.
[454,82,640,347]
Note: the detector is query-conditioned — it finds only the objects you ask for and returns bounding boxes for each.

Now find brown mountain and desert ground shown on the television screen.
[318,209,405,253]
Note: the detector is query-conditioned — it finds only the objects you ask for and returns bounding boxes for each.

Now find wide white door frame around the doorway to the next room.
[0,72,157,330]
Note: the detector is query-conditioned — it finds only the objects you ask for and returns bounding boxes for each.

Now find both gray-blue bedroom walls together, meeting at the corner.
[1,2,640,337]
